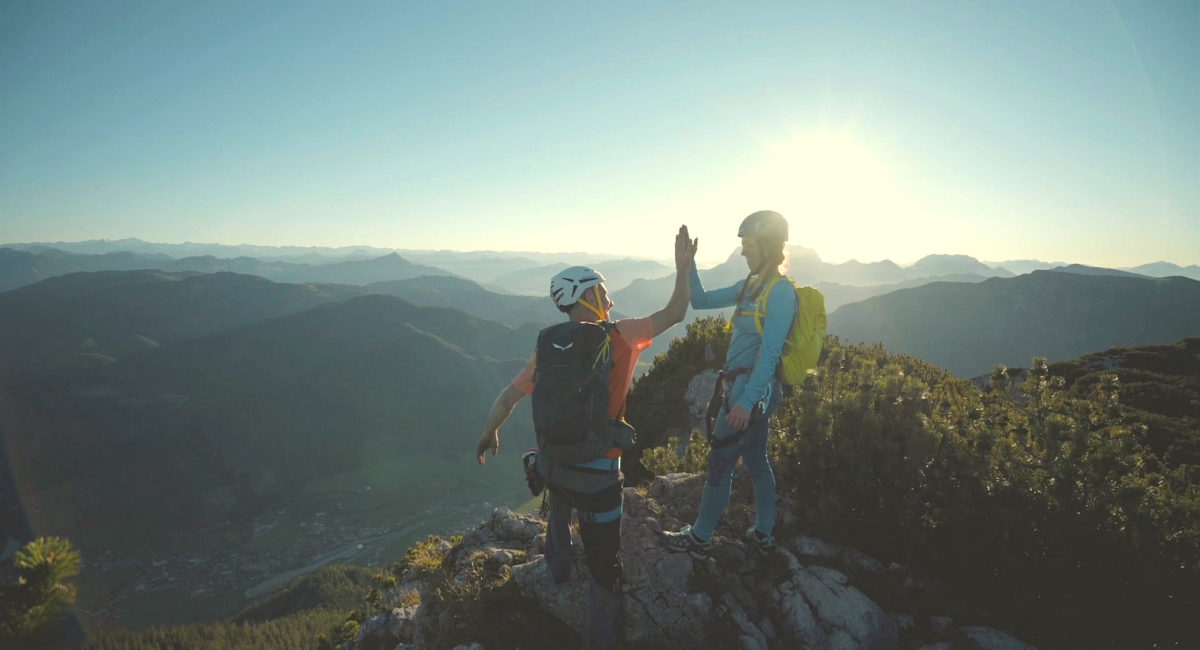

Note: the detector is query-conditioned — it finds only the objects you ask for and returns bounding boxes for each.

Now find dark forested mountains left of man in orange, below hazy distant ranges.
[0,271,536,573]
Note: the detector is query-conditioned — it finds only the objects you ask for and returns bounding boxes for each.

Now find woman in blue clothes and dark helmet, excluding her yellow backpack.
[664,210,797,553]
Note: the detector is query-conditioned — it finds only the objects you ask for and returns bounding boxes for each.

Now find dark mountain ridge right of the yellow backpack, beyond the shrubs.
[829,271,1200,377]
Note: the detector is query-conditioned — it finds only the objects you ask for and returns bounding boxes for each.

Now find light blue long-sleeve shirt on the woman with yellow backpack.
[691,264,797,411]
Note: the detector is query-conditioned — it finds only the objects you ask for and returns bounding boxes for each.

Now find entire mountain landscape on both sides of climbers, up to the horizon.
[0,241,1200,638]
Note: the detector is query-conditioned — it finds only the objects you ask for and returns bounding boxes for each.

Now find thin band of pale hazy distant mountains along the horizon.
[0,240,1200,295]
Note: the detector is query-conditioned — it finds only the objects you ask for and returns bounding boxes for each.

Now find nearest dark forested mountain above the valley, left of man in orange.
[0,284,535,628]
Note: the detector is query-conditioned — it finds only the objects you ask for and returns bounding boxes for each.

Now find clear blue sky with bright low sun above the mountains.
[0,0,1200,266]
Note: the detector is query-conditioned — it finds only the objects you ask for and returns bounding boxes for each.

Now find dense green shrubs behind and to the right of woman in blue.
[626,330,1200,648]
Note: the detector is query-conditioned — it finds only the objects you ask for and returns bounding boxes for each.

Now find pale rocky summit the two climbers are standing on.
[343,474,1031,650]
